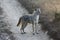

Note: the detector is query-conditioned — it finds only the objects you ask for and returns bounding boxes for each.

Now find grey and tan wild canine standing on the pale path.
[17,8,41,34]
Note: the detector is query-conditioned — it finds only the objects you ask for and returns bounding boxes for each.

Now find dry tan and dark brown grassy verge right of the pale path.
[19,0,60,40]
